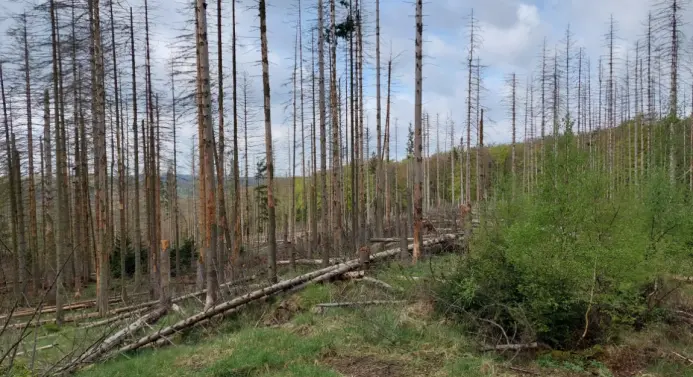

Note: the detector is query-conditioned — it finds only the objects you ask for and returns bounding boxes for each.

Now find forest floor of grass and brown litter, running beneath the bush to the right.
[8,251,693,377]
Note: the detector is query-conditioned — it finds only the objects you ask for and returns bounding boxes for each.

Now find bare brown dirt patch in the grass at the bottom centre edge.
[323,355,408,377]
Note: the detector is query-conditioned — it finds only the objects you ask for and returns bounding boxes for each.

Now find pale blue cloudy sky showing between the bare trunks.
[0,0,693,176]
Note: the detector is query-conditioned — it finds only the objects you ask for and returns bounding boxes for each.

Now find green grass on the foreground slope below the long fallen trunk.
[6,255,693,377]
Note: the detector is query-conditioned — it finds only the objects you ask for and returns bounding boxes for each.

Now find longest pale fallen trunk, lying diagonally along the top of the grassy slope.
[108,234,456,353]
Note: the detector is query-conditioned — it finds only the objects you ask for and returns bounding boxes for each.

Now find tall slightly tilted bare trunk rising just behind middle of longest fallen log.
[259,0,277,283]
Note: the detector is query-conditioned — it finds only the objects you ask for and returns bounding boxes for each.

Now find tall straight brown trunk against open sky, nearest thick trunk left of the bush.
[412,0,423,264]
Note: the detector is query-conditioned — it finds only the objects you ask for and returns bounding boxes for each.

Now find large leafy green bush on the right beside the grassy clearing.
[438,136,693,348]
